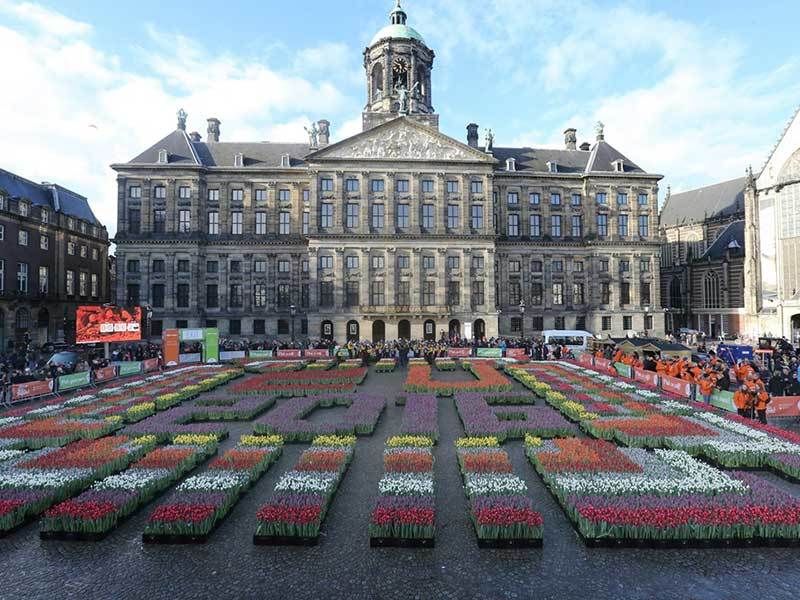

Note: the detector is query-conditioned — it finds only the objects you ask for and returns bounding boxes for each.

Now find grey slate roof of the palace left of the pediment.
[128,129,309,168]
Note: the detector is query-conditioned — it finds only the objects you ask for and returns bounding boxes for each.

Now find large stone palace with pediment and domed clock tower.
[112,3,664,341]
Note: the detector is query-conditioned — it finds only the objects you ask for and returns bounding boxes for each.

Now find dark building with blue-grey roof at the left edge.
[0,169,111,351]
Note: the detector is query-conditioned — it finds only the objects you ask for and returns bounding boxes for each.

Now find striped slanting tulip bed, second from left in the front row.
[40,436,217,540]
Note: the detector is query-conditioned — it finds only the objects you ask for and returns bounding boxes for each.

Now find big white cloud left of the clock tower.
[0,0,359,241]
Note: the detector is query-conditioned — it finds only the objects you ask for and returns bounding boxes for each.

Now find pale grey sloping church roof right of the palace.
[661,177,747,227]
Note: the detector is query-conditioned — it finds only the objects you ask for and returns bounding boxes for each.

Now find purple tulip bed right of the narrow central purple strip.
[456,394,577,441]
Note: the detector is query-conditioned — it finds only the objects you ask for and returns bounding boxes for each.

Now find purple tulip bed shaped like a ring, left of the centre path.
[254,394,386,442]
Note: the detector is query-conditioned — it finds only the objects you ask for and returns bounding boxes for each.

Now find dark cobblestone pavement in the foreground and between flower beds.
[0,372,800,600]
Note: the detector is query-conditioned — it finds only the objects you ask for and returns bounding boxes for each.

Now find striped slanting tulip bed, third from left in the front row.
[142,436,283,543]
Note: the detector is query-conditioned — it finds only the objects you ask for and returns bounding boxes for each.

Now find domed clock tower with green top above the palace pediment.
[363,0,439,131]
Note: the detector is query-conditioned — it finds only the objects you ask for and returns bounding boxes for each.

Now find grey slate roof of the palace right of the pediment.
[481,140,644,173]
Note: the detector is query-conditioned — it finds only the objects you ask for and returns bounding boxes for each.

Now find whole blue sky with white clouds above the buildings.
[0,0,800,239]
